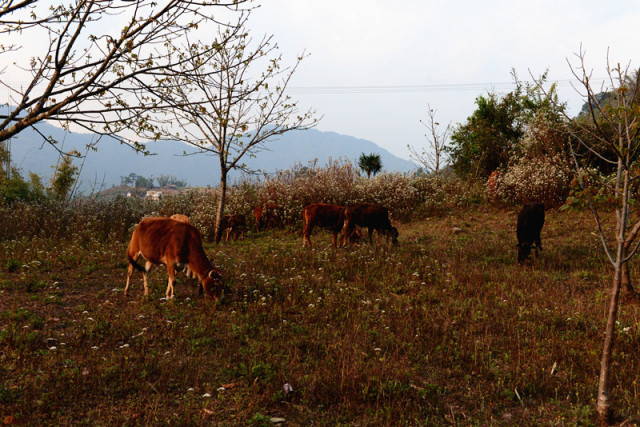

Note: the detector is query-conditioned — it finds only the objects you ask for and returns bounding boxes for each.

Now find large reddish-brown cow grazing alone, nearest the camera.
[124,218,222,300]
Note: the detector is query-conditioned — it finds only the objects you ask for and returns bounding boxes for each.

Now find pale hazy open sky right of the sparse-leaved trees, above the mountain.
[242,0,640,158]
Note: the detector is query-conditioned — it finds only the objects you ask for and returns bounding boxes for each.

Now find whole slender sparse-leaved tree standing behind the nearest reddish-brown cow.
[151,13,317,242]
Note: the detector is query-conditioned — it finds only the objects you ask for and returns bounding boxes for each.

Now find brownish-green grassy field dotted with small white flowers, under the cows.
[0,207,640,425]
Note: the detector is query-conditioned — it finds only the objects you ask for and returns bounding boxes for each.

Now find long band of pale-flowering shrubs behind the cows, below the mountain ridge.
[0,160,480,242]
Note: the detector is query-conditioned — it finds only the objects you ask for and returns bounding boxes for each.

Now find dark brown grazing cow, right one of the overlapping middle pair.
[340,203,398,246]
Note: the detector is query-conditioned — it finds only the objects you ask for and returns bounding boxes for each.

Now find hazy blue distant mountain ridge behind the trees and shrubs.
[5,123,416,192]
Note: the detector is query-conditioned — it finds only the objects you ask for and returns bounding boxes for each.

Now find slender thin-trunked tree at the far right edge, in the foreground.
[544,49,640,423]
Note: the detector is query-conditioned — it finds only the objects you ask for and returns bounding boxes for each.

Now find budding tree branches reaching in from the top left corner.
[0,0,245,149]
